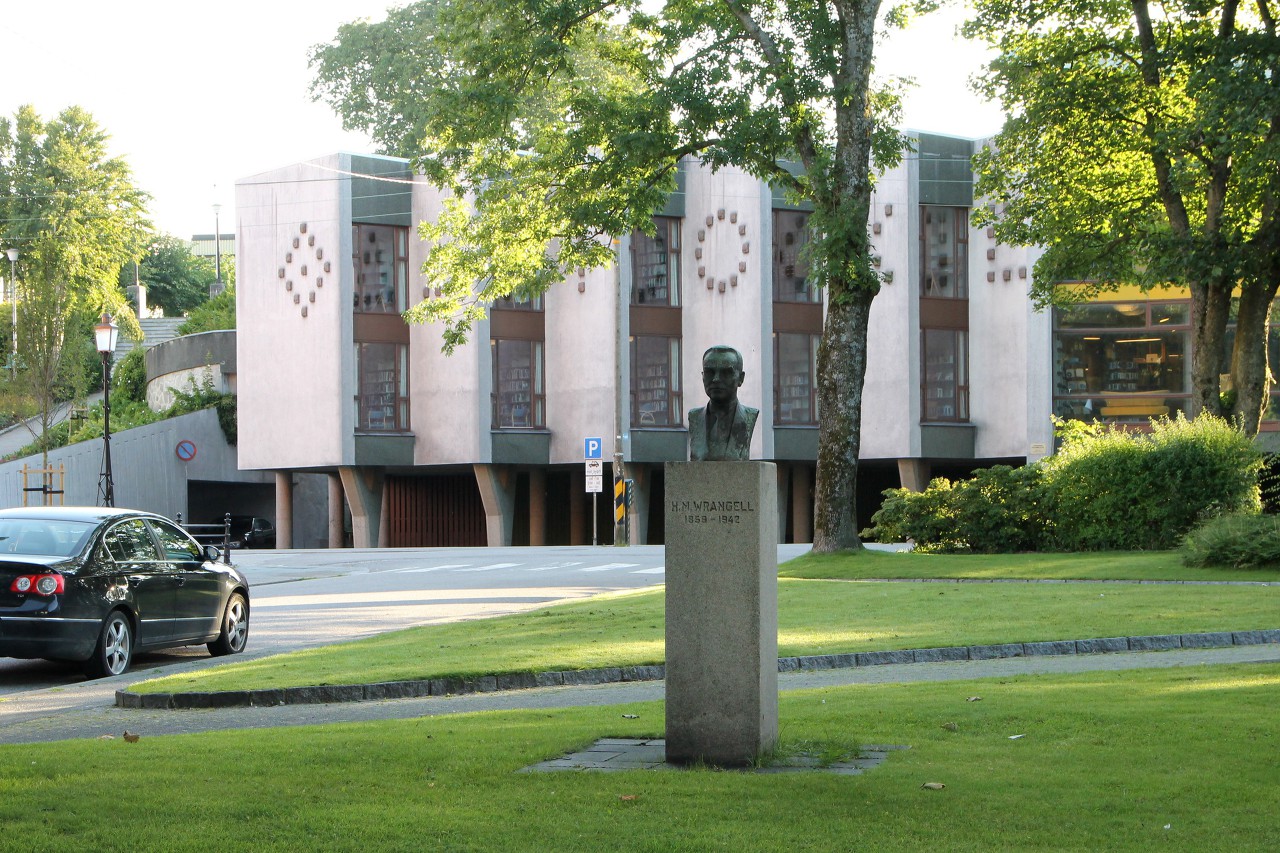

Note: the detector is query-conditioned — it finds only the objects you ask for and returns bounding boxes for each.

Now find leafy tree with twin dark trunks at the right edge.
[968,0,1280,432]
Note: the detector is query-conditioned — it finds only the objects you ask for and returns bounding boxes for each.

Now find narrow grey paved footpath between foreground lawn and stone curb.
[0,643,1280,743]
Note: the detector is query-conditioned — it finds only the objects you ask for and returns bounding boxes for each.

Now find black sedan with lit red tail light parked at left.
[0,507,248,678]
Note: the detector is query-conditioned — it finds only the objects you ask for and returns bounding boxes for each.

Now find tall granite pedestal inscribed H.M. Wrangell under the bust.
[664,462,778,767]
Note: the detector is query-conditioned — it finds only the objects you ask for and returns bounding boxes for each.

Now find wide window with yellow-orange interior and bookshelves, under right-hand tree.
[1053,301,1192,423]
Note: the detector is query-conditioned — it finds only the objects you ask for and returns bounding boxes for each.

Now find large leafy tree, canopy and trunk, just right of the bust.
[312,0,902,549]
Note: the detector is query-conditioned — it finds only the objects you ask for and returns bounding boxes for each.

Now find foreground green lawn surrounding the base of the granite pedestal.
[0,665,1280,853]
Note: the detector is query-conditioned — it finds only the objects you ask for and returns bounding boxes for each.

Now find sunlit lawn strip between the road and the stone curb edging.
[133,553,1280,692]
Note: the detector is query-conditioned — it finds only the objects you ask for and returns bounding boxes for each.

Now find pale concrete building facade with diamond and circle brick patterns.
[237,134,1055,547]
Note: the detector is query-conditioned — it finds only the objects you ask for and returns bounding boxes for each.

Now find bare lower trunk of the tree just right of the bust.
[813,289,876,553]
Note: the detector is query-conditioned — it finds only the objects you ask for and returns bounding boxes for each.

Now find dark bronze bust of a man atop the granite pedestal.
[689,346,760,462]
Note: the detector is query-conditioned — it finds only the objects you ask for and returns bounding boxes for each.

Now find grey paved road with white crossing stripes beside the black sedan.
[0,546,732,696]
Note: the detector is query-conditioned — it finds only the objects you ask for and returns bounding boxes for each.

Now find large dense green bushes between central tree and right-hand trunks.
[863,414,1262,553]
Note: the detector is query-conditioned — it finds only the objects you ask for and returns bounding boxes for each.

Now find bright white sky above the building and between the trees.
[0,0,1001,237]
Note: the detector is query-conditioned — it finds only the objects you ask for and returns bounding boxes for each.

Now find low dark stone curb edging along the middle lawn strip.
[115,629,1280,710]
